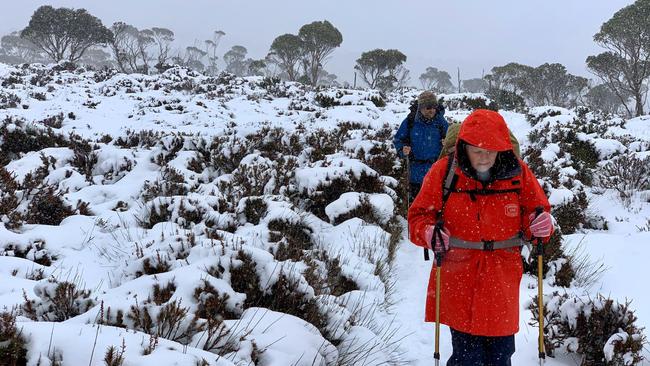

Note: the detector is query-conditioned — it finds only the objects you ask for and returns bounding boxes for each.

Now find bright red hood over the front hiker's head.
[456,109,513,151]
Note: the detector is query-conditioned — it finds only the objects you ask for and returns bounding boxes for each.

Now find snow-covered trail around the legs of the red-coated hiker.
[394,237,580,366]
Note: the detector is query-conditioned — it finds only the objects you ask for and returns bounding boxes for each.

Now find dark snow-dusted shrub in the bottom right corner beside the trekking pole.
[528,291,646,366]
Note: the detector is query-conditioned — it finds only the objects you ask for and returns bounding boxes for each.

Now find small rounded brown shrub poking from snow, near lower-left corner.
[22,278,95,322]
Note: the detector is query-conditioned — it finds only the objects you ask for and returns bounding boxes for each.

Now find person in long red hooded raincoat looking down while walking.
[408,110,553,366]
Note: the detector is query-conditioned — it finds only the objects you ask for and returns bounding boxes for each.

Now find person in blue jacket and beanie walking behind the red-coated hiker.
[393,91,449,205]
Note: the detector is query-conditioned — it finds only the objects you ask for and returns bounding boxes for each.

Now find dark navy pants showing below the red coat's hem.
[447,328,515,366]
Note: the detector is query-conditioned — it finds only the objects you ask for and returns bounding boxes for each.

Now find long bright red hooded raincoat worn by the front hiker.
[408,110,550,336]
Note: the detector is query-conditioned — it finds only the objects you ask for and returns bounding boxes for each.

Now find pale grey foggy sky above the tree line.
[0,0,634,85]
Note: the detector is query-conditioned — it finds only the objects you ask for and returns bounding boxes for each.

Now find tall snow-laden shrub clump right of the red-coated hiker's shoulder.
[523,107,624,234]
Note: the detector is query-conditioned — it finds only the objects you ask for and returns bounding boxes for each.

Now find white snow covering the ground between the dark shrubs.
[0,65,650,366]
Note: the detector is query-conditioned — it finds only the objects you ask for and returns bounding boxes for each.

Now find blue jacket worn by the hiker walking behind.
[393,109,449,184]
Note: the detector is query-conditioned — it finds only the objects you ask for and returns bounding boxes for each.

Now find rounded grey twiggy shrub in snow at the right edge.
[597,154,650,205]
